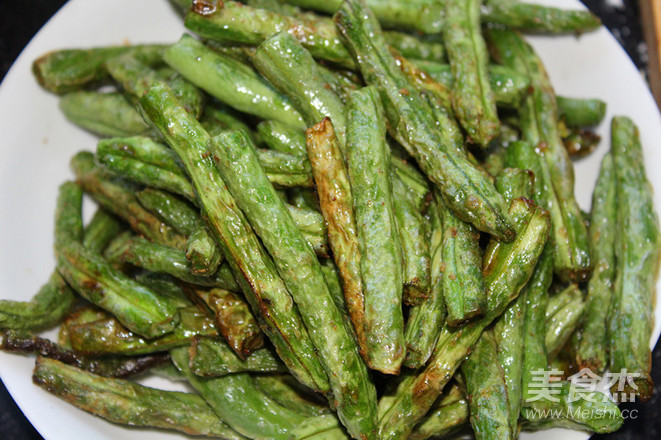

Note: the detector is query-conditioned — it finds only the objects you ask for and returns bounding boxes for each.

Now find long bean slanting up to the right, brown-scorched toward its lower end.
[379,199,549,439]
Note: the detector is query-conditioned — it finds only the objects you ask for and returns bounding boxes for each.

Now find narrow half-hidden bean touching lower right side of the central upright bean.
[404,193,446,368]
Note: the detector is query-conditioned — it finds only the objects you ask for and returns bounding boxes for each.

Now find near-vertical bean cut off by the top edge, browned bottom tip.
[443,0,500,148]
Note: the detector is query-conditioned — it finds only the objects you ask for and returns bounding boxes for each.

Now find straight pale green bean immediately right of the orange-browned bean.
[346,87,406,374]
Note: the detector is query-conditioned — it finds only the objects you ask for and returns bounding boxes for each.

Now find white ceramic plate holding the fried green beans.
[0,0,661,440]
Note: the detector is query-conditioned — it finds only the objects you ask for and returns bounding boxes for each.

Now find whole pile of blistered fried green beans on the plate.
[0,0,661,440]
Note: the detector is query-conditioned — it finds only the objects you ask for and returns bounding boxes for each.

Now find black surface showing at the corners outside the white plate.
[0,0,661,440]
